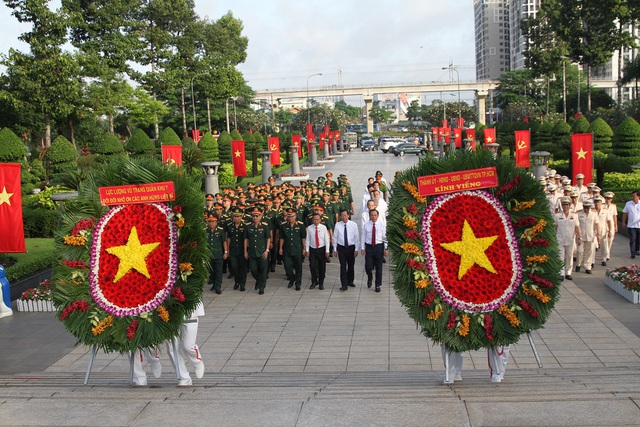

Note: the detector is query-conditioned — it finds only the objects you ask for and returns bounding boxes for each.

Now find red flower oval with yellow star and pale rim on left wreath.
[89,204,177,316]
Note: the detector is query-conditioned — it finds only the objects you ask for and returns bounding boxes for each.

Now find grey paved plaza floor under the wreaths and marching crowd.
[0,151,640,426]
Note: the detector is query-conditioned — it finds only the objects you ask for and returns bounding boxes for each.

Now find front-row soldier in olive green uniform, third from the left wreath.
[244,206,271,295]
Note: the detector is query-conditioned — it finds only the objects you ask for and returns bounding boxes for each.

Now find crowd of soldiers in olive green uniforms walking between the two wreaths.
[204,172,387,295]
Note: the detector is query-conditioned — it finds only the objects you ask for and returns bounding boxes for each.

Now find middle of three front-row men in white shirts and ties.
[333,209,360,291]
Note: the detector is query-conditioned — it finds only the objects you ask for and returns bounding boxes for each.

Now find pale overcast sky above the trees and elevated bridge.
[0,0,475,102]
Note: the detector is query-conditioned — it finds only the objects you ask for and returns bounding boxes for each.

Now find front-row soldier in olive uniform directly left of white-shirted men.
[279,208,307,291]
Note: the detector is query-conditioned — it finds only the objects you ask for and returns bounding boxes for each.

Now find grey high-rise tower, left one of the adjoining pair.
[473,0,511,81]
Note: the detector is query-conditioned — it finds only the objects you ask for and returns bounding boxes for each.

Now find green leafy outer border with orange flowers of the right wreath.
[387,150,562,352]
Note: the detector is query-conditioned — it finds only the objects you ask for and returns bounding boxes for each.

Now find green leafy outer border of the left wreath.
[52,158,210,353]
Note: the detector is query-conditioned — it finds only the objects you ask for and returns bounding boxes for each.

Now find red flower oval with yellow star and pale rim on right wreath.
[422,191,522,312]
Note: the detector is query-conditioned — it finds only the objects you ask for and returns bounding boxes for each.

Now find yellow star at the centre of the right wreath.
[440,219,498,280]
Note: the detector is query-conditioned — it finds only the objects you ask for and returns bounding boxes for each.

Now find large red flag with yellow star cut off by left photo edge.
[0,163,27,253]
